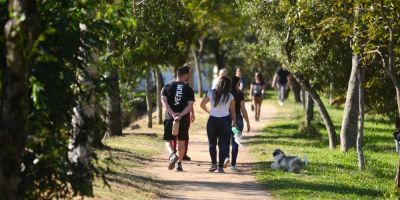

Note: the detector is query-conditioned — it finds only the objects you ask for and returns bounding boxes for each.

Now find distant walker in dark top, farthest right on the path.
[272,64,290,106]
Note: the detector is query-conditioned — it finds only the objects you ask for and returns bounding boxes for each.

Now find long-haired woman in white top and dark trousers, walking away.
[200,76,237,173]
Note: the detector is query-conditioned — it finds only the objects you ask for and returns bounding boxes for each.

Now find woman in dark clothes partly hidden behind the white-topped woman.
[231,76,250,171]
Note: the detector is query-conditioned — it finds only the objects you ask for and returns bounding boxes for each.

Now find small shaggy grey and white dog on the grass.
[271,149,308,173]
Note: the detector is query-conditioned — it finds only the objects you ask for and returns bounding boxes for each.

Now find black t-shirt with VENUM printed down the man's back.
[161,81,194,119]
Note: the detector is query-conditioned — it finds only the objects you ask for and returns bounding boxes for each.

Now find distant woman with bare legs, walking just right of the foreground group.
[250,72,265,121]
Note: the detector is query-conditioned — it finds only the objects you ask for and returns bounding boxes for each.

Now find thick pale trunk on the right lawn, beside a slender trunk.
[340,54,360,151]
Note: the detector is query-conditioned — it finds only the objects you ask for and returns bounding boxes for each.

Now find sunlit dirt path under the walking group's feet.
[142,101,276,200]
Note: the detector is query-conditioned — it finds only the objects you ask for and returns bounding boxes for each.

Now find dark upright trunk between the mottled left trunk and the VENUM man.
[106,66,122,136]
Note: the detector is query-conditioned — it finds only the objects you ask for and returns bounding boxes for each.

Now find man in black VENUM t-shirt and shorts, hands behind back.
[161,66,194,171]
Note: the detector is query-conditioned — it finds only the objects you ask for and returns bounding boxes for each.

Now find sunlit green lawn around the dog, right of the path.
[250,93,398,199]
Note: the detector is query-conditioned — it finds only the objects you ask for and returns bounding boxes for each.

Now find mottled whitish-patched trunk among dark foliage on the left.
[68,66,99,196]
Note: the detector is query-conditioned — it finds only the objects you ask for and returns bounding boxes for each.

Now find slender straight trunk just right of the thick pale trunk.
[357,68,365,171]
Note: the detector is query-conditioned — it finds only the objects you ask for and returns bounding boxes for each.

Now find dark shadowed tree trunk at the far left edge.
[0,0,39,200]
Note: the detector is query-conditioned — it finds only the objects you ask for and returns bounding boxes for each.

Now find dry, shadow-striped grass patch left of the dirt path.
[94,135,162,200]
